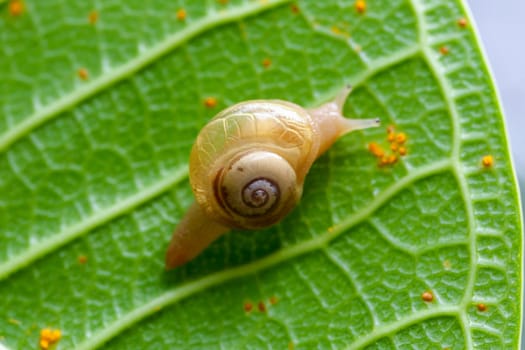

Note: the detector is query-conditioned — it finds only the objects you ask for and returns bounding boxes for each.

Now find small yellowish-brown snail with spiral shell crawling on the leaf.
[166,86,379,269]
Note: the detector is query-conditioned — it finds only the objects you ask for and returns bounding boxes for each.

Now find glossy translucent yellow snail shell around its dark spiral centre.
[190,100,319,229]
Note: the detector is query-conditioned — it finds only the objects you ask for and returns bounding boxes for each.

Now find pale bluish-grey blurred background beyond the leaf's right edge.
[467,0,525,349]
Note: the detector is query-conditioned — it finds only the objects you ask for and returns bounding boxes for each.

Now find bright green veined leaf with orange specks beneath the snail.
[0,0,522,349]
